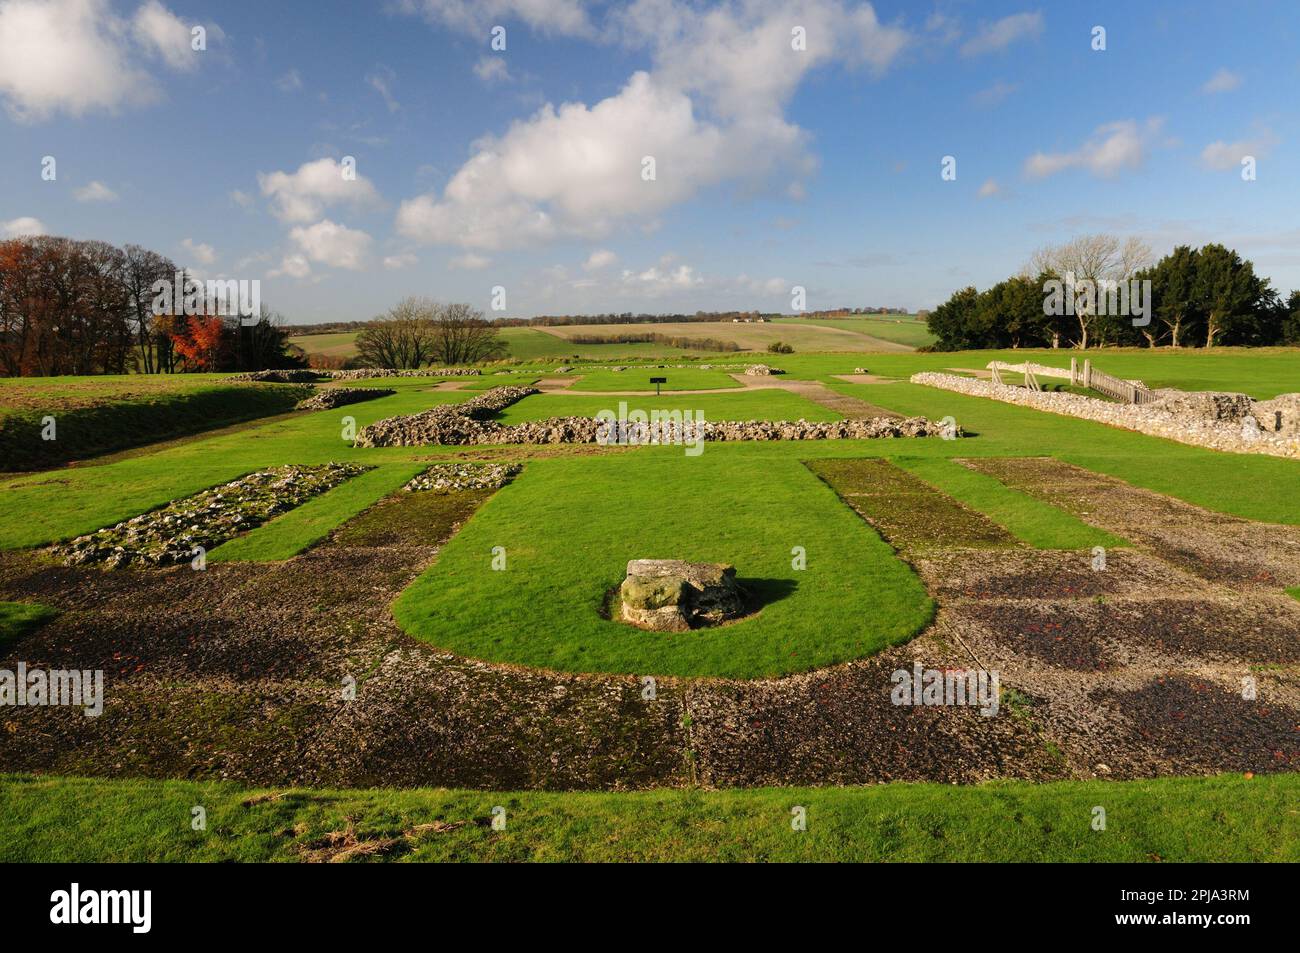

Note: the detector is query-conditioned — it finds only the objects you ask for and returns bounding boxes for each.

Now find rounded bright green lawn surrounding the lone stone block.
[394,447,933,677]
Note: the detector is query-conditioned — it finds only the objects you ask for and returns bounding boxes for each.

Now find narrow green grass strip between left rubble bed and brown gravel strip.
[208,463,425,563]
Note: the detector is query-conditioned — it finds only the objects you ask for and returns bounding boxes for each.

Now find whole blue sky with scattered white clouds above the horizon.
[0,0,1300,324]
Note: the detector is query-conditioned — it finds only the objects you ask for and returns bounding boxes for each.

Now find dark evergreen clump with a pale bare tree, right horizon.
[927,235,1300,351]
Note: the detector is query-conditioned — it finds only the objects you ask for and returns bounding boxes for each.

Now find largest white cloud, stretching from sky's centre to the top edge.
[397,0,910,251]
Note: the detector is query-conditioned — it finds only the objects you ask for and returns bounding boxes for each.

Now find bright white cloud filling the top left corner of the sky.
[0,0,155,121]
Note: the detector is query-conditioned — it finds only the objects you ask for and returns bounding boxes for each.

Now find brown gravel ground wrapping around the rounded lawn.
[0,460,1300,789]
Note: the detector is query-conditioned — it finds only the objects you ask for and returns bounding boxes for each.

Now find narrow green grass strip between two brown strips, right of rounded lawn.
[894,456,1126,549]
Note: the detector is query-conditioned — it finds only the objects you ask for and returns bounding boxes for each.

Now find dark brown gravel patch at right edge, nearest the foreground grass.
[1092,676,1300,771]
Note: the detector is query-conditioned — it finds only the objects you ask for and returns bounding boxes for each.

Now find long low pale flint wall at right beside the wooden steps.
[911,371,1300,458]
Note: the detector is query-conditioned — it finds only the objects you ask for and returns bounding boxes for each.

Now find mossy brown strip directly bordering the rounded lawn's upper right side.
[807,459,1018,550]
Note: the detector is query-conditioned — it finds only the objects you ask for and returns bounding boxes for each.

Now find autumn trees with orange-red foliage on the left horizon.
[0,235,302,377]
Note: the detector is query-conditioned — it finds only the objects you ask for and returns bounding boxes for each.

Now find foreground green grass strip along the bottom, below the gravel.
[0,775,1300,863]
